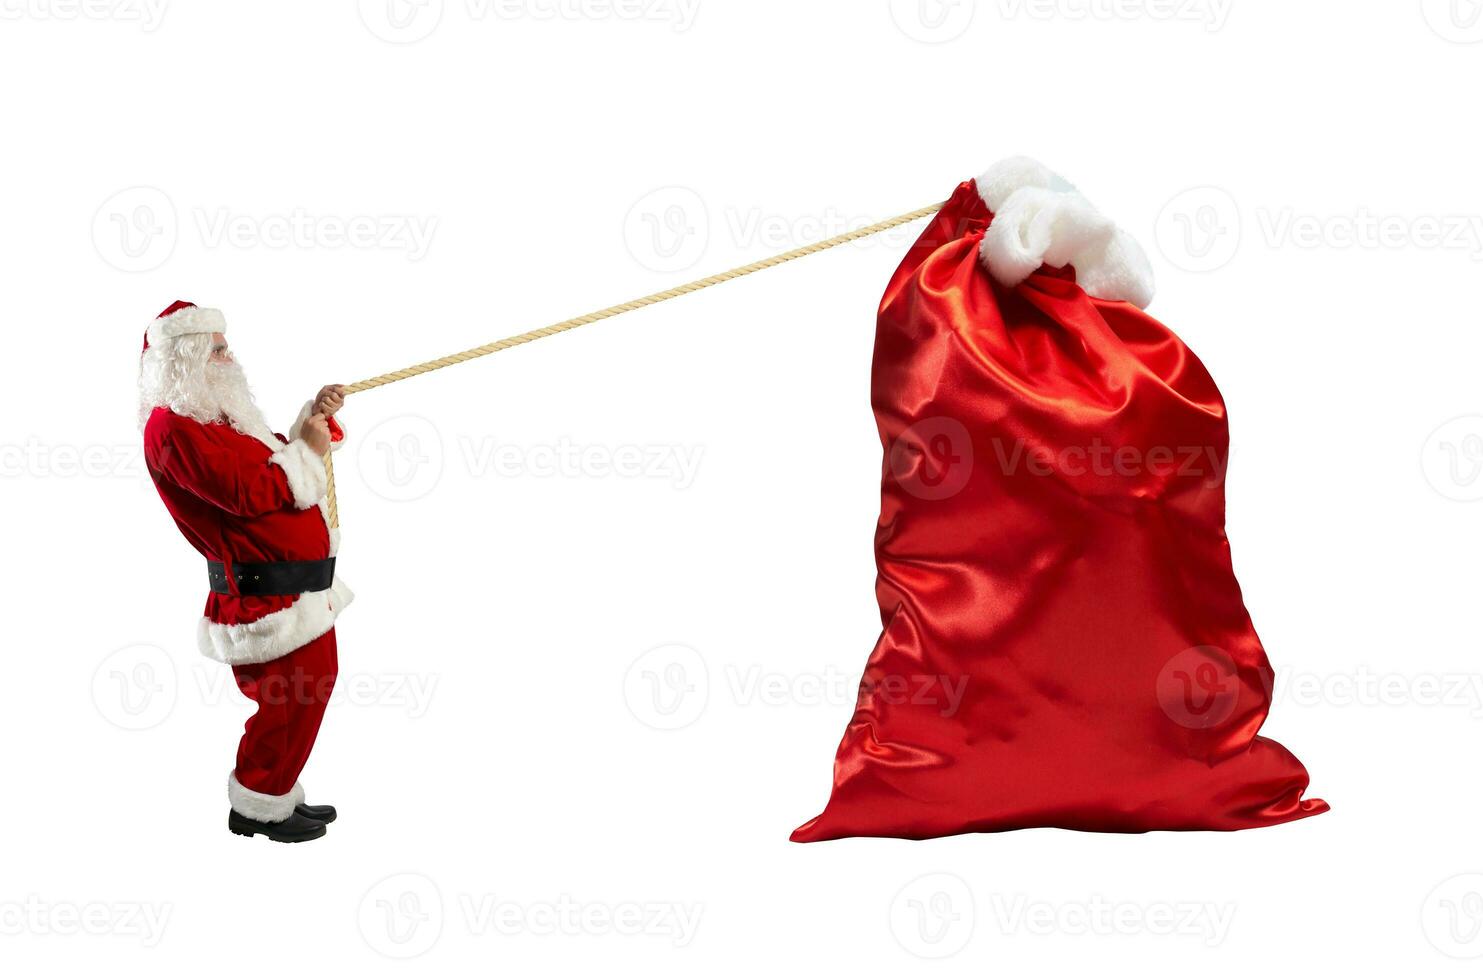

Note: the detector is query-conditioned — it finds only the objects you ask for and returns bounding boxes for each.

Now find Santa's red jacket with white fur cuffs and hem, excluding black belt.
[144,408,353,664]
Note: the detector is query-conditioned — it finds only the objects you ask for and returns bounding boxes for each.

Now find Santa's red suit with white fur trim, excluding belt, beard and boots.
[144,304,353,823]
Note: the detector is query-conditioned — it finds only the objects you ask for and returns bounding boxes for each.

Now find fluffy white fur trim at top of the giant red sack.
[976,157,1154,307]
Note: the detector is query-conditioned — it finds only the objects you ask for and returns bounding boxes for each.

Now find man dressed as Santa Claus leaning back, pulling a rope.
[139,302,351,842]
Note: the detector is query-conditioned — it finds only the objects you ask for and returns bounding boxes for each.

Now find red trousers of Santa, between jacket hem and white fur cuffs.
[231,629,338,796]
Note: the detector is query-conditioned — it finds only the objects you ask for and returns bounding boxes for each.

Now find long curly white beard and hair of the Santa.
[139,334,280,446]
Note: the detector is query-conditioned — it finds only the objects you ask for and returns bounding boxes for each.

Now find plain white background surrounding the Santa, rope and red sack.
[0,0,1483,979]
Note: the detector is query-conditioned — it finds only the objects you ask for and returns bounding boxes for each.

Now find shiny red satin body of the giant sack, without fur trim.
[793,181,1327,842]
